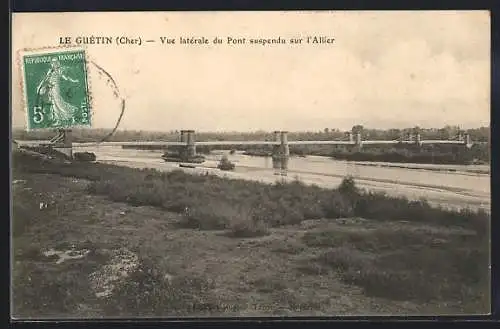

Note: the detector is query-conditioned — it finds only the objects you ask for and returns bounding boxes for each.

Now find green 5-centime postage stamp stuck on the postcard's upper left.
[20,48,91,130]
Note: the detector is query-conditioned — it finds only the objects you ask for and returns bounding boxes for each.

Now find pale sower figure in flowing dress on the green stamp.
[37,58,78,125]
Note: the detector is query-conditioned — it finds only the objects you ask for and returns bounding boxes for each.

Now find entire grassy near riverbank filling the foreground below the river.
[13,153,489,316]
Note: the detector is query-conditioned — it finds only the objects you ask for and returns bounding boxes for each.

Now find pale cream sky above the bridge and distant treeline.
[12,11,490,131]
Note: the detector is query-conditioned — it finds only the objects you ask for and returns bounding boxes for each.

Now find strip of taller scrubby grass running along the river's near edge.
[13,150,489,234]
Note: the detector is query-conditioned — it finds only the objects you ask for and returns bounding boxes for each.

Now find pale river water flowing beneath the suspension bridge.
[74,145,491,210]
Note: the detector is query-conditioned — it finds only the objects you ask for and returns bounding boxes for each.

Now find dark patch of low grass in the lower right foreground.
[302,228,489,302]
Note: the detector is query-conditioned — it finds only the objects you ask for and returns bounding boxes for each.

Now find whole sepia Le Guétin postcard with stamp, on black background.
[11,11,491,320]
